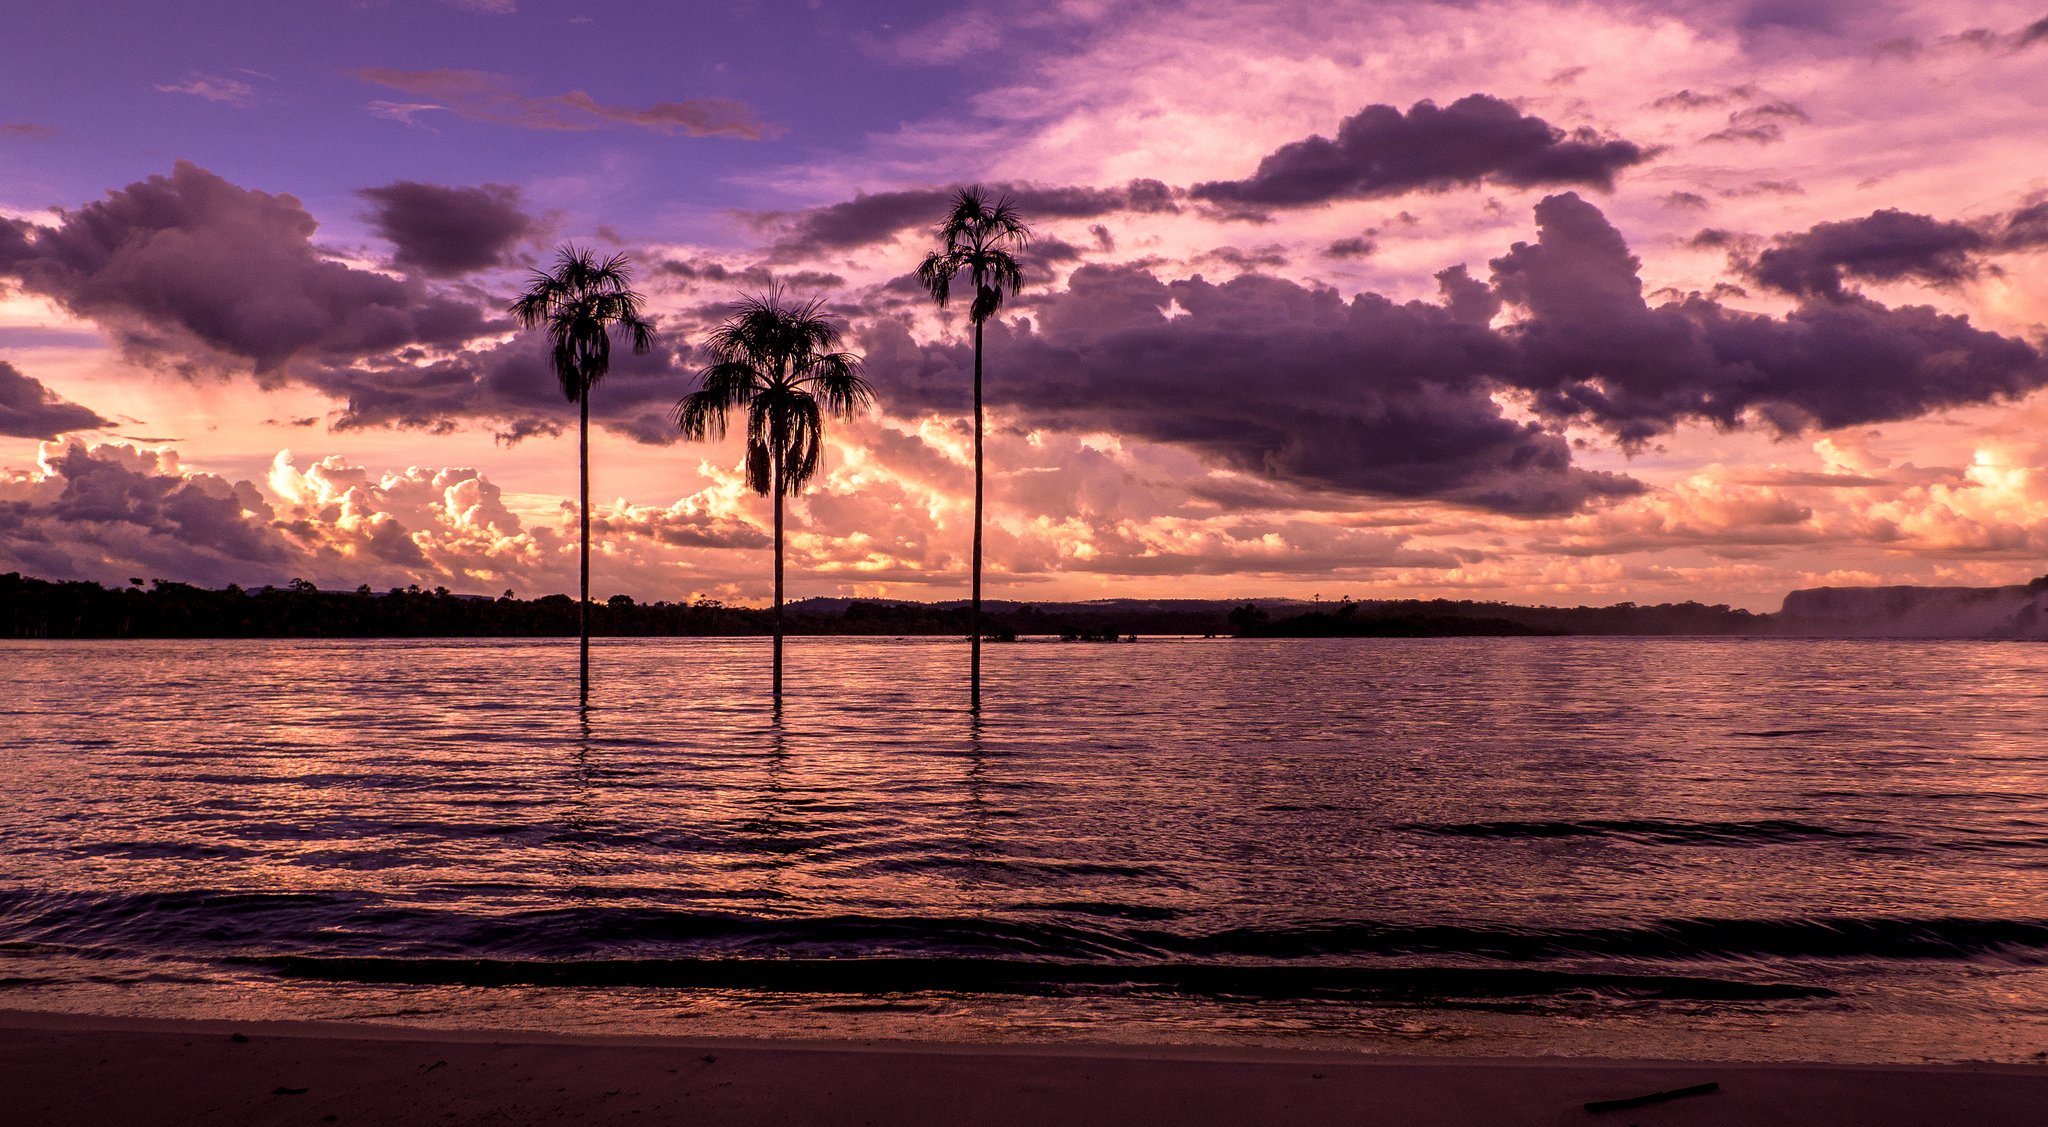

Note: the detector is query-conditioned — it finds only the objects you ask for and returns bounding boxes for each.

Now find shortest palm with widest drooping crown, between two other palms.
[676,289,874,709]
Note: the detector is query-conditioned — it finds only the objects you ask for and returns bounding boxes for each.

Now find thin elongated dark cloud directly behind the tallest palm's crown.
[754,180,1180,254]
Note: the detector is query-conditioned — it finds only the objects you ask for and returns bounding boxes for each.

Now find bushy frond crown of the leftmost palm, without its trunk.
[512,244,653,404]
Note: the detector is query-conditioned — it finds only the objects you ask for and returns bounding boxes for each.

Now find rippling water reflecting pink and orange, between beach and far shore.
[0,639,2048,1061]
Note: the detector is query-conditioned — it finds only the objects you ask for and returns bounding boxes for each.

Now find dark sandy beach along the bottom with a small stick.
[0,1012,2048,1127]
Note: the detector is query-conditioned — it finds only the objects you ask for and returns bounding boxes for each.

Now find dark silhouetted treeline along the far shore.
[0,572,1769,641]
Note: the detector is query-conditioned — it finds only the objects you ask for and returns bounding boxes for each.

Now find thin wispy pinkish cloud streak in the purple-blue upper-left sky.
[348,66,782,141]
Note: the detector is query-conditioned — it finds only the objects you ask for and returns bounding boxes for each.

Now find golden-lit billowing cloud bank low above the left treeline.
[0,441,766,594]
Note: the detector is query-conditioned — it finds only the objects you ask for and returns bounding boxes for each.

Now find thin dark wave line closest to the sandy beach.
[238,955,1833,1002]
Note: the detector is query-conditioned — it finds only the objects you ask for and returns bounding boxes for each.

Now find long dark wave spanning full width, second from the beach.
[12,889,2048,963]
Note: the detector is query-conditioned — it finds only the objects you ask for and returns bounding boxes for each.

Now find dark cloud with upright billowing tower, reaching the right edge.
[1493,193,2048,443]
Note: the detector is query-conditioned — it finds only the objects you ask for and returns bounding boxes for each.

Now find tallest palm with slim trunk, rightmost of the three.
[918,186,1030,713]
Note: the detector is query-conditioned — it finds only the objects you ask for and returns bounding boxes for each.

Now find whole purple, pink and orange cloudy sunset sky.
[0,0,2048,611]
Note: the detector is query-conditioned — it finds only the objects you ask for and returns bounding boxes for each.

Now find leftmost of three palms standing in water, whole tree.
[512,244,653,711]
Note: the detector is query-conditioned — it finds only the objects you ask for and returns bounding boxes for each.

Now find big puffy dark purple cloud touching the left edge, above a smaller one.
[0,162,492,383]
